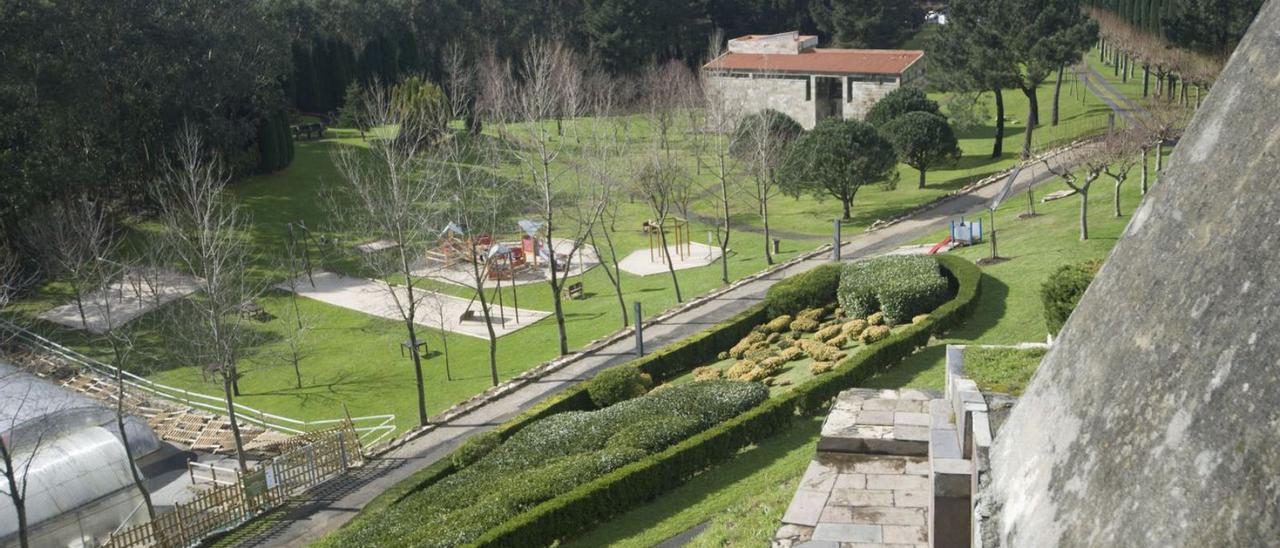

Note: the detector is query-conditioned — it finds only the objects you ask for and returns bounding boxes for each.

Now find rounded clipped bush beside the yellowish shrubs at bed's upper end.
[837,256,948,325]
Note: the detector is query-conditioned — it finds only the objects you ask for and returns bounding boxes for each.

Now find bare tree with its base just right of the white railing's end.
[332,82,449,426]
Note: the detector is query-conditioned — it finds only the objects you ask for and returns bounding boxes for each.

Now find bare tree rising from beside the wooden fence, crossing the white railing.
[152,127,264,470]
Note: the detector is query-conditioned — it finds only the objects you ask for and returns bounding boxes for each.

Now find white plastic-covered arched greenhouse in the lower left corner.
[0,361,161,547]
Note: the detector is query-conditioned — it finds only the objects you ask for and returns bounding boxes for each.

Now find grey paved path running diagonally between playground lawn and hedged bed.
[225,143,1084,547]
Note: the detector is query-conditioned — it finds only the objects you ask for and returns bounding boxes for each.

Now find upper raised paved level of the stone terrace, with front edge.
[818,388,938,457]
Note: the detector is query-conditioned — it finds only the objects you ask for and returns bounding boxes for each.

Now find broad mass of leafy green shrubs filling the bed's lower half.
[325,380,769,547]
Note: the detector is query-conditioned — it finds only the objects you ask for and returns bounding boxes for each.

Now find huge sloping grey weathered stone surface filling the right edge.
[978,1,1280,547]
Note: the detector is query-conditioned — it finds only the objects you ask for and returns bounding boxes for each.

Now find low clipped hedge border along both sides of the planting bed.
[326,255,982,547]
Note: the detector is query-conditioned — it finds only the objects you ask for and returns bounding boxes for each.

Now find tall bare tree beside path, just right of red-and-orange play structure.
[485,40,604,355]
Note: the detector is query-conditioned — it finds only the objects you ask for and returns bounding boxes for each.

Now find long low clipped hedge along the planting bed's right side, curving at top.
[472,256,982,547]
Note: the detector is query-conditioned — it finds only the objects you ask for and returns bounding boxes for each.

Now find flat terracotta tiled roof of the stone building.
[703,47,924,74]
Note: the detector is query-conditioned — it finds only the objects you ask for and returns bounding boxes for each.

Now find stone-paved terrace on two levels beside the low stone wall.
[773,389,936,548]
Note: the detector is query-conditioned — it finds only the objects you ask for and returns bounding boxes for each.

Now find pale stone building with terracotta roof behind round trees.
[703,31,924,129]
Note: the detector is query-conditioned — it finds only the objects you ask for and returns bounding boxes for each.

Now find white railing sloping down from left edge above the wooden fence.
[0,319,396,449]
